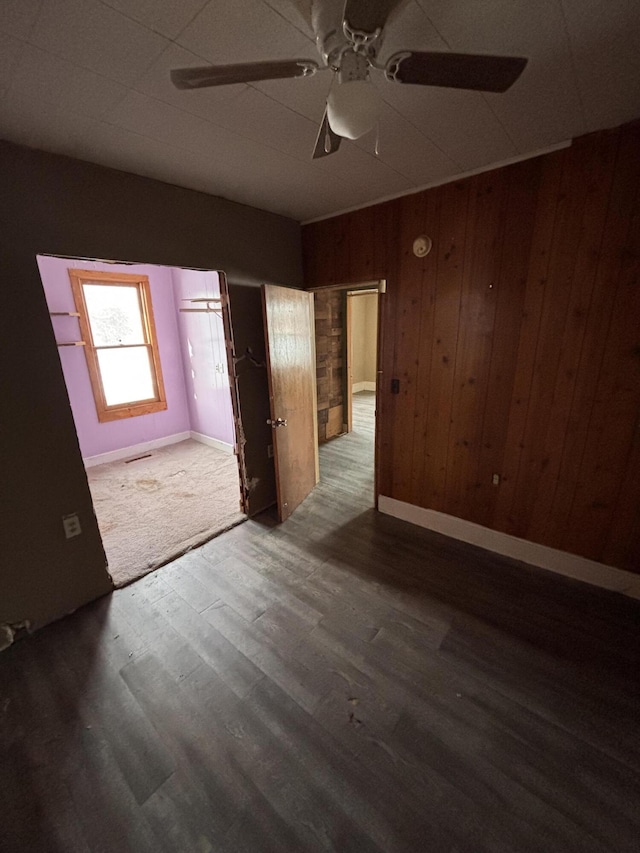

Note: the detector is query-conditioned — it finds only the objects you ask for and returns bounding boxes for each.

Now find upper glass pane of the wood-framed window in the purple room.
[83,284,146,347]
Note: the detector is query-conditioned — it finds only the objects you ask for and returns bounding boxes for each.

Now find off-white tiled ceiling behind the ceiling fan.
[0,0,640,221]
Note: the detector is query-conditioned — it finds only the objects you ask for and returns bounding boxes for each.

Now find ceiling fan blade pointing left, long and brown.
[171,59,319,89]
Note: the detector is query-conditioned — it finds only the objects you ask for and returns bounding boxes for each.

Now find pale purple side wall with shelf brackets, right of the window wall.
[172,269,235,444]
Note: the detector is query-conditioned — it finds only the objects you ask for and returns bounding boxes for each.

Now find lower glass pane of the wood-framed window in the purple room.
[97,347,156,406]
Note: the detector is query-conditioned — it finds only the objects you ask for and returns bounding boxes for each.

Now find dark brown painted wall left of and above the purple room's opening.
[0,143,302,626]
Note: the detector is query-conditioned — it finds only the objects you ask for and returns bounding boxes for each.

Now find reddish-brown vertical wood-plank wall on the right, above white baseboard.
[303,123,640,571]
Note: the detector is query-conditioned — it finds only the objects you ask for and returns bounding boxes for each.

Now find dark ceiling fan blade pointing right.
[385,50,527,92]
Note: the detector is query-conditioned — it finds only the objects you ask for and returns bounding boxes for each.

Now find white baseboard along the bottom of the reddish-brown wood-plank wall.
[378,495,640,599]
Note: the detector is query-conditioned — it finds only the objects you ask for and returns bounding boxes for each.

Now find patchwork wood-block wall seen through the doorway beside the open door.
[315,290,345,442]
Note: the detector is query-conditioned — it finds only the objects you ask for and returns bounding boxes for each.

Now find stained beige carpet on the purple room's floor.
[87,440,246,586]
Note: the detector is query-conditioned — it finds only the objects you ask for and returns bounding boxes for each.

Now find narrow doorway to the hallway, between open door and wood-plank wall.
[314,281,385,503]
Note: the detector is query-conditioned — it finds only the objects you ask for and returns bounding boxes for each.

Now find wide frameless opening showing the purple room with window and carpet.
[37,255,246,587]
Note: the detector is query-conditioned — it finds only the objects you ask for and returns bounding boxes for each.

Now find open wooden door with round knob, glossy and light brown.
[262,284,319,521]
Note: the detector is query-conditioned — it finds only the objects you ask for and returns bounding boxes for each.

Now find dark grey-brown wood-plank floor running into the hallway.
[0,394,640,853]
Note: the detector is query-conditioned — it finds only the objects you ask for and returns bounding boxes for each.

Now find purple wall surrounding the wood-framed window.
[38,255,190,459]
